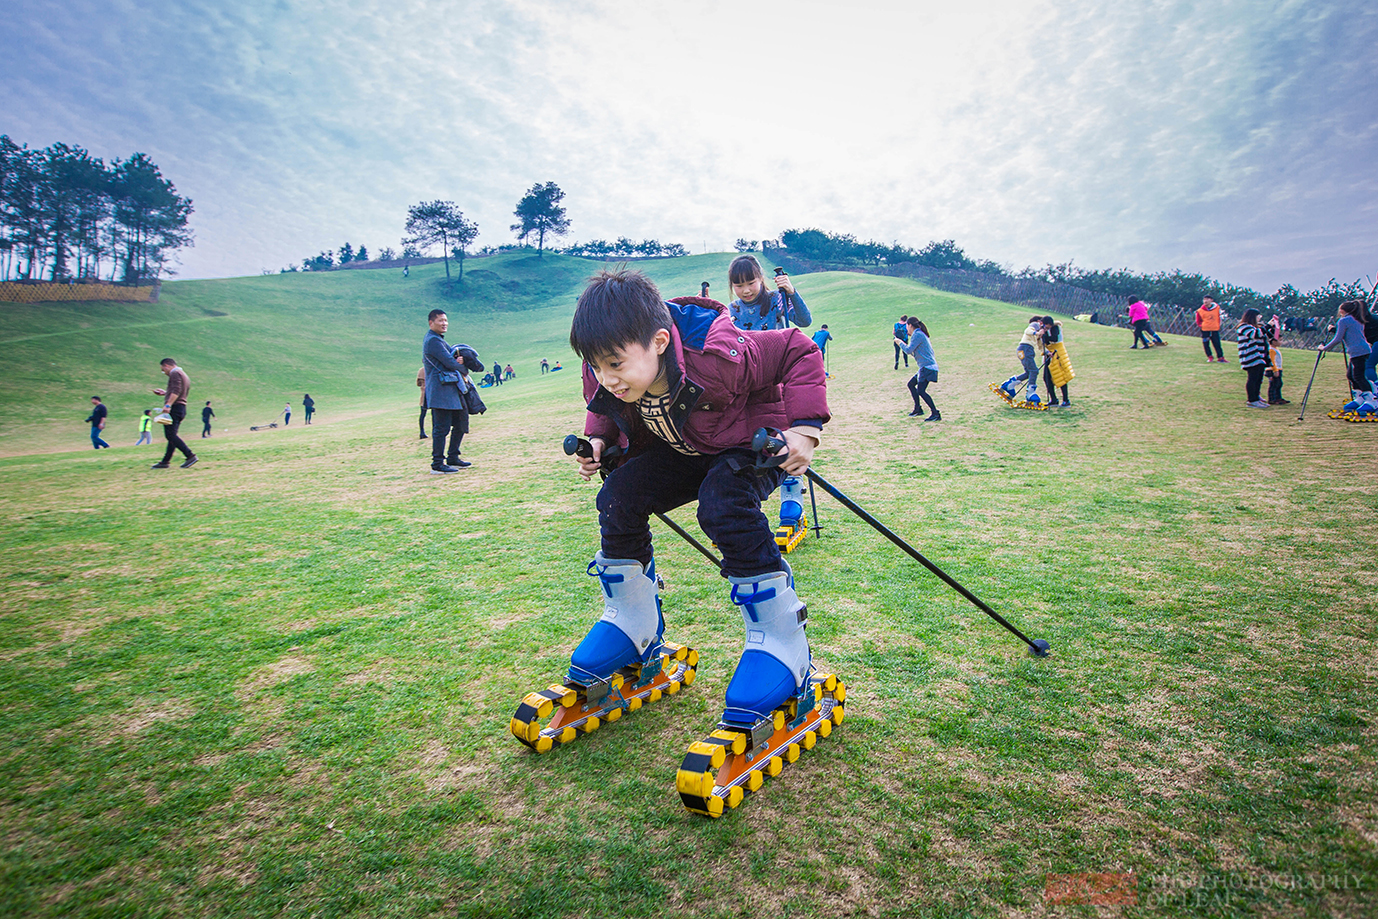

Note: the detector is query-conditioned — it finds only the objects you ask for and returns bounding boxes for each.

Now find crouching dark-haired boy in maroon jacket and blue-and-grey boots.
[569,271,830,726]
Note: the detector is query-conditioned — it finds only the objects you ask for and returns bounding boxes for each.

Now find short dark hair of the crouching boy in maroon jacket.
[569,269,674,361]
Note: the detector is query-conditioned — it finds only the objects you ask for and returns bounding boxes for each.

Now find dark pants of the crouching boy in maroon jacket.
[598,441,784,577]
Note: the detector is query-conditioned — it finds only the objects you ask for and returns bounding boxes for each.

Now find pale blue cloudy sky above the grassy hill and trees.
[0,0,1378,292]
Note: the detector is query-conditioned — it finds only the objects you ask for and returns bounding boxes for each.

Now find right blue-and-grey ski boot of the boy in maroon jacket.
[722,559,810,727]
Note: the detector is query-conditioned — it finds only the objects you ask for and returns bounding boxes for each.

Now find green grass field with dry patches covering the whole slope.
[0,255,1378,919]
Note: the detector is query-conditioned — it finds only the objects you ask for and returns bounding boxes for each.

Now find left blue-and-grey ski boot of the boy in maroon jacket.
[569,553,666,685]
